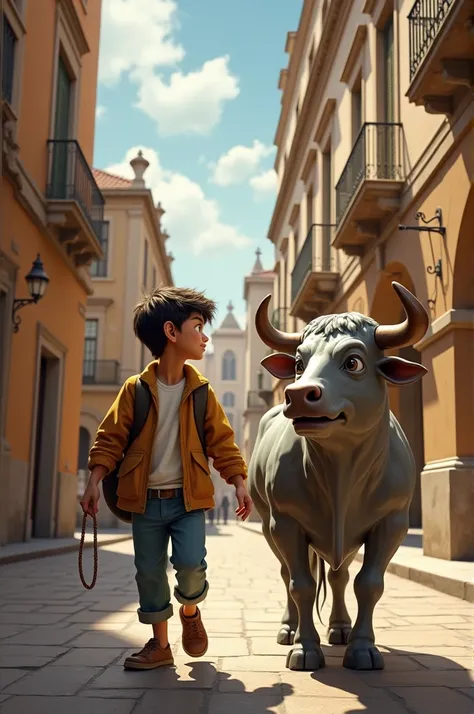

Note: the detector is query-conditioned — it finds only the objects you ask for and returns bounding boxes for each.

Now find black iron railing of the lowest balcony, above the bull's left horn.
[291,223,335,302]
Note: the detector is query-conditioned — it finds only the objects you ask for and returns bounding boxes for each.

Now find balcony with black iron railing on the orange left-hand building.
[46,139,106,267]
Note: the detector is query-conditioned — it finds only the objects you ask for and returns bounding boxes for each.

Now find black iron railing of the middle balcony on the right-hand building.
[336,122,404,224]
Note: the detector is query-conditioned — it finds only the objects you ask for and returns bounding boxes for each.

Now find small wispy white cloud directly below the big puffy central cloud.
[211,139,275,186]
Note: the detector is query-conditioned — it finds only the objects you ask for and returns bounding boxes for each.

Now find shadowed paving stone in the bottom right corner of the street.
[392,686,473,714]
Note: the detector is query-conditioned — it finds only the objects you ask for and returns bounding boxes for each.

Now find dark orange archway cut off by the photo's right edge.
[453,187,474,310]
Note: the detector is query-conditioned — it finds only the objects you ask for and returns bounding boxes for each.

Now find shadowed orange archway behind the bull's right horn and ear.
[370,262,425,528]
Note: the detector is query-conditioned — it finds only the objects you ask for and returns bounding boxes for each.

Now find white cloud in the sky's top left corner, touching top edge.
[99,0,185,85]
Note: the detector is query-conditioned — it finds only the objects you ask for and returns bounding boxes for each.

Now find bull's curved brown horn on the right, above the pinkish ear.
[375,281,430,350]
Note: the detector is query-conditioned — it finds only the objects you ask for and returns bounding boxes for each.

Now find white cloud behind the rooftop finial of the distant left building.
[105,146,252,255]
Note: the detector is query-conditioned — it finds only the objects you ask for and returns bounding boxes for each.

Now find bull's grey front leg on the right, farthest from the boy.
[343,510,408,669]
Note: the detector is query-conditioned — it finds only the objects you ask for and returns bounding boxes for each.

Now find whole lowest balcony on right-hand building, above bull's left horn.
[290,223,339,322]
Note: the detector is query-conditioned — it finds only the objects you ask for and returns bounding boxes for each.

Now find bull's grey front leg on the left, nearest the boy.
[271,513,325,671]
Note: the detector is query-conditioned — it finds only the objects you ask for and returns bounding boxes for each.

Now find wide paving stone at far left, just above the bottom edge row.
[4,666,100,696]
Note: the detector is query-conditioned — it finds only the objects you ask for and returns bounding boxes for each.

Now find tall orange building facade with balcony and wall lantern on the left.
[0,0,104,544]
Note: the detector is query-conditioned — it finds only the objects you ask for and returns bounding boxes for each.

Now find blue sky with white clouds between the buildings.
[94,0,302,326]
